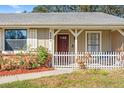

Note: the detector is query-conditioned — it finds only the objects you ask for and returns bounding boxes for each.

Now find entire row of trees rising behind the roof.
[32,5,124,17]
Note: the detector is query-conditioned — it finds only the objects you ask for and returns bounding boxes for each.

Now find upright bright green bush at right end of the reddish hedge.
[38,47,48,65]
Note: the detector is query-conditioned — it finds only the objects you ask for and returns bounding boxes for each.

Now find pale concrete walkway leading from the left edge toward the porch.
[0,69,73,84]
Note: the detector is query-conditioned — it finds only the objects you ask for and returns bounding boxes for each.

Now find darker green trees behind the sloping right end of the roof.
[80,5,124,17]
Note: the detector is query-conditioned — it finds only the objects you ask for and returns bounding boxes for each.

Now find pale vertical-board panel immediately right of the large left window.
[27,29,37,49]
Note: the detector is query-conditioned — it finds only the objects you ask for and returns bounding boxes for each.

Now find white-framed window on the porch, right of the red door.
[87,32,100,52]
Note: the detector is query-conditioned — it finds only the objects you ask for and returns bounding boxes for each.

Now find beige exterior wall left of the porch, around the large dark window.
[0,28,49,53]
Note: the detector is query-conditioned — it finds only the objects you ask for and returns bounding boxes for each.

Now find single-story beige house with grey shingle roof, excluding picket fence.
[0,12,124,68]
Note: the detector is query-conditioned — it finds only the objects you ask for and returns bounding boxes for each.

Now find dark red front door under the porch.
[57,35,69,52]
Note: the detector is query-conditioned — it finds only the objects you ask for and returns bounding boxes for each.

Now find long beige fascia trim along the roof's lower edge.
[0,24,124,30]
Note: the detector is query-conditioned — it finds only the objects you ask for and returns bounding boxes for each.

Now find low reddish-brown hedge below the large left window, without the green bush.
[0,54,40,71]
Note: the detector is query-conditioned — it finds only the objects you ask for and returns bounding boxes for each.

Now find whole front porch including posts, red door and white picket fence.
[50,28,124,69]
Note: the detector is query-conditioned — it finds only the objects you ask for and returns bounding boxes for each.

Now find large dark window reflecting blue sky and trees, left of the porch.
[5,29,27,51]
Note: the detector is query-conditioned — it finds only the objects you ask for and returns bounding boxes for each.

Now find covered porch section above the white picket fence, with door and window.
[49,28,124,54]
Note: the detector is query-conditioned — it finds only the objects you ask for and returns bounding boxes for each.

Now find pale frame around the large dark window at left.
[3,28,28,52]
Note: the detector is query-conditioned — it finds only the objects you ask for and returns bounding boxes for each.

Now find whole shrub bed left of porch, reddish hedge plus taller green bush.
[0,47,51,71]
